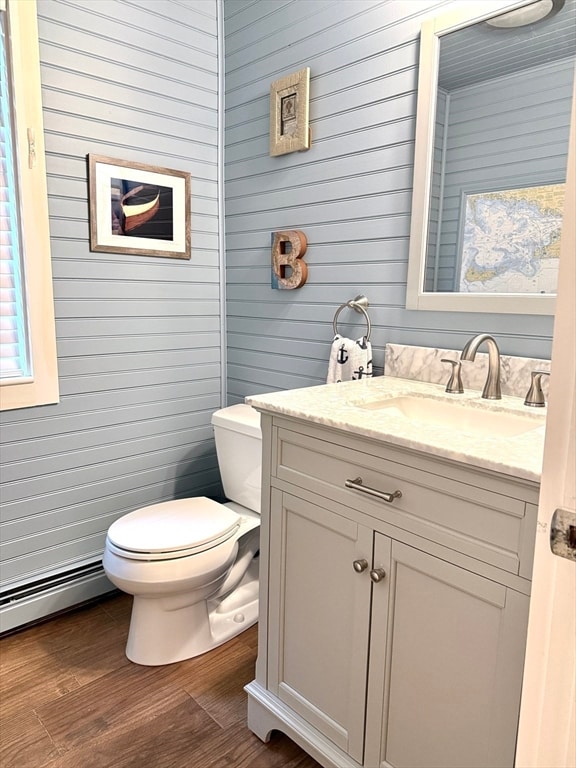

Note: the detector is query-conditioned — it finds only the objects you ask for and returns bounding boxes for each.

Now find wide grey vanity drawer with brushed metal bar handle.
[272,420,534,575]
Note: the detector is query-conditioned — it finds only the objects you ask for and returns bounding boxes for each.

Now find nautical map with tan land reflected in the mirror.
[457,183,565,295]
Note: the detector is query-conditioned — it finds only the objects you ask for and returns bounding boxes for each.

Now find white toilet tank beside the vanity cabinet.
[212,403,262,513]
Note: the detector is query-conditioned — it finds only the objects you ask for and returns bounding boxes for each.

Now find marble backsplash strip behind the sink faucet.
[384,344,550,398]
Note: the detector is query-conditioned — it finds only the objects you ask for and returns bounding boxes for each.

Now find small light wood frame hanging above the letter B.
[270,67,311,157]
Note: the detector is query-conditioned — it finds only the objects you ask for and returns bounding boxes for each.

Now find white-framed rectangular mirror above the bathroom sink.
[406,0,576,315]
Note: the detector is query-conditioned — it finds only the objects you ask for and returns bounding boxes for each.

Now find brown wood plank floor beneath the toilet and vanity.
[0,595,320,768]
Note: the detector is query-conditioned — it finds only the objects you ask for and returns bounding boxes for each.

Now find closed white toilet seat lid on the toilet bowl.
[107,496,242,561]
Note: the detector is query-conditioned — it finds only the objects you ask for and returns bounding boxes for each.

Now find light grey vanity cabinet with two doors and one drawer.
[247,413,538,768]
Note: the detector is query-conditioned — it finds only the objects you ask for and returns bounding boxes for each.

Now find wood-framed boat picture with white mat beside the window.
[88,155,191,259]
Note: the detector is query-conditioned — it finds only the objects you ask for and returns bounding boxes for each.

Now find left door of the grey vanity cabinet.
[268,491,373,763]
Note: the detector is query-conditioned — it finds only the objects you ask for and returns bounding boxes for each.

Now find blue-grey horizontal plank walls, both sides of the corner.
[0,0,568,632]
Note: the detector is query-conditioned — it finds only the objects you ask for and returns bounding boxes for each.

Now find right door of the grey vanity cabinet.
[367,536,528,768]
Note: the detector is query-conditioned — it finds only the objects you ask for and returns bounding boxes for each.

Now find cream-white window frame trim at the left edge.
[0,0,59,411]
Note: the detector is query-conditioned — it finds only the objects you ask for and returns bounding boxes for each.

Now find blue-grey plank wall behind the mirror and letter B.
[224,0,553,401]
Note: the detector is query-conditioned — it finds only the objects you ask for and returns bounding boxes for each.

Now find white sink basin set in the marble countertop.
[357,395,545,437]
